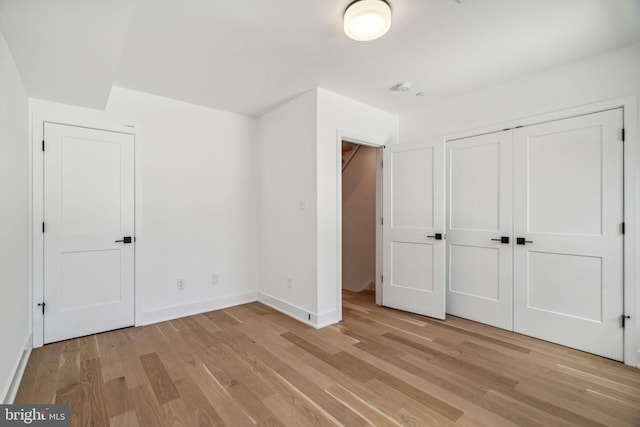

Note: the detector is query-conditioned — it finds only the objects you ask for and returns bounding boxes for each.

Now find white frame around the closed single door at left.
[30,112,142,348]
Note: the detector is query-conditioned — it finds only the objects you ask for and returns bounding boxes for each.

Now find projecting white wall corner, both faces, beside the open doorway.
[259,89,398,327]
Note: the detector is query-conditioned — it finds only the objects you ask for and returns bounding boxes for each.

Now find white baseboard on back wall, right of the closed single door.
[136,292,257,326]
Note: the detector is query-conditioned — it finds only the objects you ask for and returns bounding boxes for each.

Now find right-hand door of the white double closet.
[514,109,623,360]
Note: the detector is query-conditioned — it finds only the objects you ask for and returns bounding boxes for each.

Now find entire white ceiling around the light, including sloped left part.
[0,0,640,116]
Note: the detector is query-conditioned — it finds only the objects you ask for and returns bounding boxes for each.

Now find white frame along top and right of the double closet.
[445,96,640,368]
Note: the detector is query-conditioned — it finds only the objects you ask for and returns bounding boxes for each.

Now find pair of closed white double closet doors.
[446,109,624,360]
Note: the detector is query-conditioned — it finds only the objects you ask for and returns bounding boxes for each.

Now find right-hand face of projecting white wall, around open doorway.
[316,89,399,326]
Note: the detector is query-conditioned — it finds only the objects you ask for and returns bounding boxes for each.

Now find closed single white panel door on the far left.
[44,123,134,343]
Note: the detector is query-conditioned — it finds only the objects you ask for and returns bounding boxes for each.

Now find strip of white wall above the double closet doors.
[400,43,640,143]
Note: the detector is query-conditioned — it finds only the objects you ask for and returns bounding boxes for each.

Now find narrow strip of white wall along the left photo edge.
[0,30,31,403]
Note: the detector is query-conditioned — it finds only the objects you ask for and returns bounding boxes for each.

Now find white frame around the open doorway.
[336,130,385,310]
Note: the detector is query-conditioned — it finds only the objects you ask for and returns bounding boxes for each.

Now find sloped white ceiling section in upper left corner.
[0,0,135,109]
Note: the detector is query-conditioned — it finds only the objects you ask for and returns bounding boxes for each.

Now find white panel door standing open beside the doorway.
[382,141,445,319]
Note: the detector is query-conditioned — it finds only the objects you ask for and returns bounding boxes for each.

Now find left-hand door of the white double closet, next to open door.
[447,131,513,329]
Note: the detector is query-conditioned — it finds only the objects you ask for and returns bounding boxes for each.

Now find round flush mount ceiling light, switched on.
[344,0,391,41]
